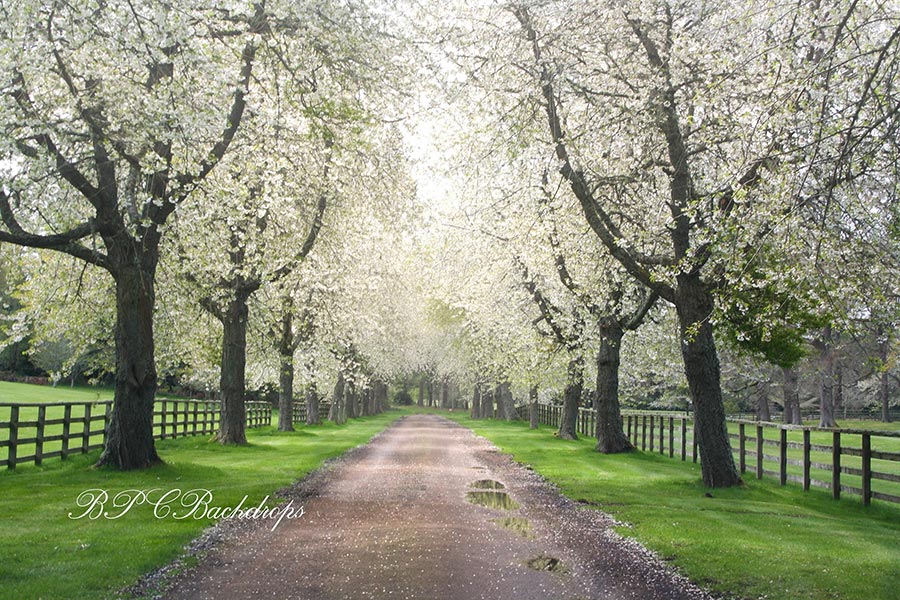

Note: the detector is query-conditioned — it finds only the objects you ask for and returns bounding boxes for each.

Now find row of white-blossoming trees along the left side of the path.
[0,0,412,469]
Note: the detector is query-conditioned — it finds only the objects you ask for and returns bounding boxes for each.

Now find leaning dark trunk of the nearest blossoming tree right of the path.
[675,274,741,487]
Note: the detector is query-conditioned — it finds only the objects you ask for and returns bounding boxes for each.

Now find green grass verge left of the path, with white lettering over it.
[0,411,402,600]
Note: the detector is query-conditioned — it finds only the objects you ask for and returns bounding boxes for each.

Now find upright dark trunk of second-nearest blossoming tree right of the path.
[594,328,634,454]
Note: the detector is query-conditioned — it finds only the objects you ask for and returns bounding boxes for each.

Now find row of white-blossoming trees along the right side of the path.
[412,1,900,487]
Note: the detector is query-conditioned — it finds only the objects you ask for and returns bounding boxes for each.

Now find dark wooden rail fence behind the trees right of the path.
[520,404,900,505]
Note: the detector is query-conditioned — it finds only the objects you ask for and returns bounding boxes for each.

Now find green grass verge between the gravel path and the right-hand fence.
[447,412,900,600]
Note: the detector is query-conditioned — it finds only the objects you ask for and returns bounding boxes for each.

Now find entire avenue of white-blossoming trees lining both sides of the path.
[0,0,900,486]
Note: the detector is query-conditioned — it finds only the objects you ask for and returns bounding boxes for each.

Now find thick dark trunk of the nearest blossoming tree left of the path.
[97,260,162,470]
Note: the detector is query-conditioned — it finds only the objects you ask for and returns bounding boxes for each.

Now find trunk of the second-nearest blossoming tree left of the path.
[217,290,250,444]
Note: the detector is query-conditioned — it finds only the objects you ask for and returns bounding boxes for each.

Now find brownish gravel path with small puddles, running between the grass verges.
[158,415,709,600]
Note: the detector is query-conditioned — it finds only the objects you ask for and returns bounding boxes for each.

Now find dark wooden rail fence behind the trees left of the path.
[0,398,272,469]
